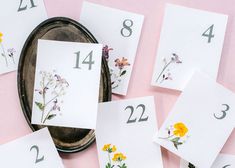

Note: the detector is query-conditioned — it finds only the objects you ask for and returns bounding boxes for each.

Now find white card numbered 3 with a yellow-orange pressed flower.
[154,72,235,168]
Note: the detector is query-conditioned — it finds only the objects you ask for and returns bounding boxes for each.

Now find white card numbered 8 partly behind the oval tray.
[80,2,144,95]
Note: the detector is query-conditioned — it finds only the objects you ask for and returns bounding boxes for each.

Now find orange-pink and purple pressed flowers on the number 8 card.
[103,45,130,89]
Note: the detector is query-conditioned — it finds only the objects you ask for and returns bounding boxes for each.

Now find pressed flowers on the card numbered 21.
[0,32,16,67]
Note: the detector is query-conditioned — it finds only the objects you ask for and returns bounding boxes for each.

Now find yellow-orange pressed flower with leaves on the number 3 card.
[159,122,188,149]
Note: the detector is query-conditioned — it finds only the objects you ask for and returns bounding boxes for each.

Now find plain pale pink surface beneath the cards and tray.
[0,0,235,168]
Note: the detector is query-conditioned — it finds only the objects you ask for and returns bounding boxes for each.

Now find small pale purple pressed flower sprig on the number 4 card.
[156,53,182,83]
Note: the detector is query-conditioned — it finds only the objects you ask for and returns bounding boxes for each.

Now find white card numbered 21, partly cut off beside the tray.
[0,0,47,74]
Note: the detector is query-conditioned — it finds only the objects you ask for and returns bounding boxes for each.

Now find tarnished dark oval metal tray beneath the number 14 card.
[17,17,111,153]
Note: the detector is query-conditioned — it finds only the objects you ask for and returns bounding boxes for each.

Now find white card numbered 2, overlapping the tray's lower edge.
[0,128,64,168]
